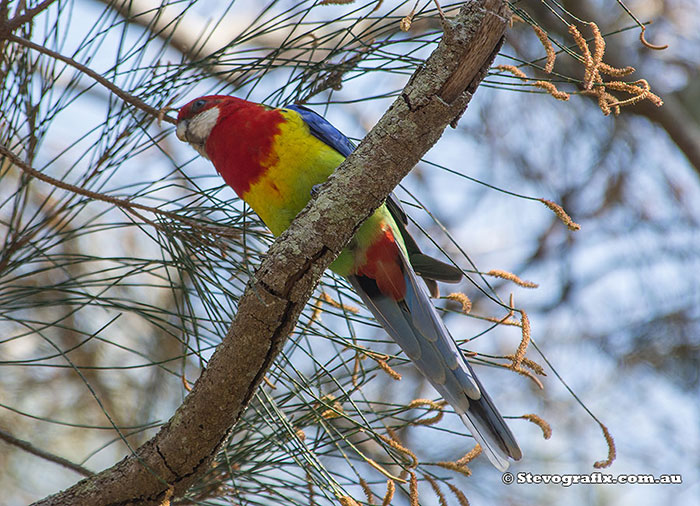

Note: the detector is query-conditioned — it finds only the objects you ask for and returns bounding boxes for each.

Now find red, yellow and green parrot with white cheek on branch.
[176,95,522,471]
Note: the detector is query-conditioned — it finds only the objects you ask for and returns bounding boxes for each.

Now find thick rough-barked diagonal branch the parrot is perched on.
[32,0,510,505]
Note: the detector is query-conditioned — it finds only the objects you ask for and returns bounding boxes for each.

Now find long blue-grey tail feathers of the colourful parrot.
[349,255,522,471]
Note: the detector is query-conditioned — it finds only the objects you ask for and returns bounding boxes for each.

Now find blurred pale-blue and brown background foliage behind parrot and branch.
[0,0,700,505]
